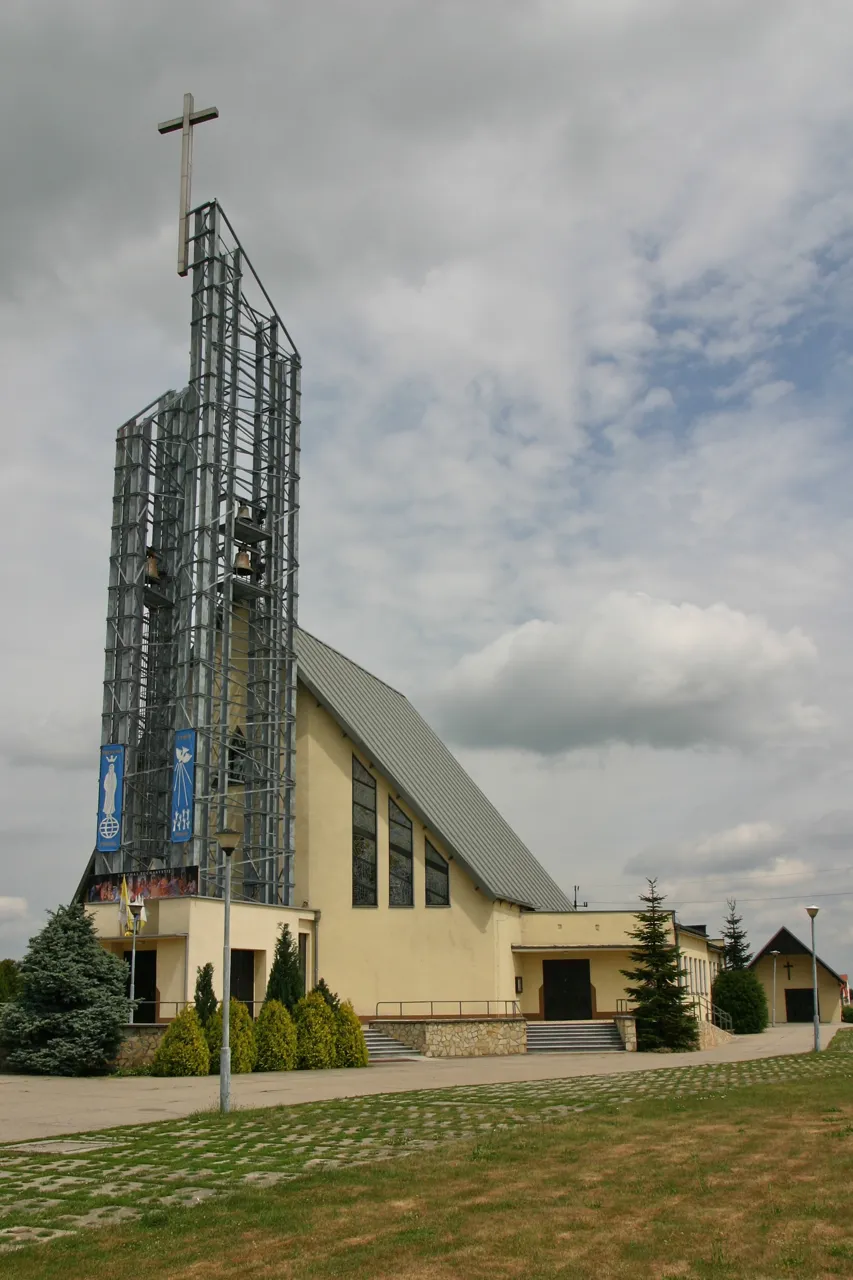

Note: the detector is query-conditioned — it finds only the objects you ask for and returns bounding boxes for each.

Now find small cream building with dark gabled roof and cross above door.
[749,928,844,1023]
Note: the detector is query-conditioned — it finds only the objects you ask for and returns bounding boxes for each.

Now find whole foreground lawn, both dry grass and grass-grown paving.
[0,1032,853,1280]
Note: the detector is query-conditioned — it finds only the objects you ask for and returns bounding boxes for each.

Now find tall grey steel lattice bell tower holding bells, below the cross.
[93,201,301,905]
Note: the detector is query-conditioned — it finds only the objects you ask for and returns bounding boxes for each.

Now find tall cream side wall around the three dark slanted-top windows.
[296,689,521,1015]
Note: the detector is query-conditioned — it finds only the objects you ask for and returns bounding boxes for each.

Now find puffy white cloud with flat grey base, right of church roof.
[439,593,824,755]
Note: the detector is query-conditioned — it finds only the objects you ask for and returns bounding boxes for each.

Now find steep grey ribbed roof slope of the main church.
[295,628,573,911]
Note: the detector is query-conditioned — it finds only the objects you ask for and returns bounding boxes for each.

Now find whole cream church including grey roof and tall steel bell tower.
[78,185,720,1051]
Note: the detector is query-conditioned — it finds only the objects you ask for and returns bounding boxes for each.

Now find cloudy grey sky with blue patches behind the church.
[0,0,853,969]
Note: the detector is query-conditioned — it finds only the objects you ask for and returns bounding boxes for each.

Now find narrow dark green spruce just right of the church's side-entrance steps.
[622,879,698,1052]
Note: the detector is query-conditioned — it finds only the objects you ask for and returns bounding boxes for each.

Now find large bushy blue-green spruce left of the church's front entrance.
[0,902,131,1075]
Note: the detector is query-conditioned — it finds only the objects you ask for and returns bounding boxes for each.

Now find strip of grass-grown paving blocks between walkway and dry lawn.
[0,1032,853,1252]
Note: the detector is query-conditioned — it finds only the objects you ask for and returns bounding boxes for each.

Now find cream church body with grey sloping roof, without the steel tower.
[87,630,721,1044]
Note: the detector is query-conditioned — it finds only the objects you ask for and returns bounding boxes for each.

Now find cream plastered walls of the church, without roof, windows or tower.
[90,687,719,1020]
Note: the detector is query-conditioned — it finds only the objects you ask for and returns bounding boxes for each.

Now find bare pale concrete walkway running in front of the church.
[0,1024,838,1142]
